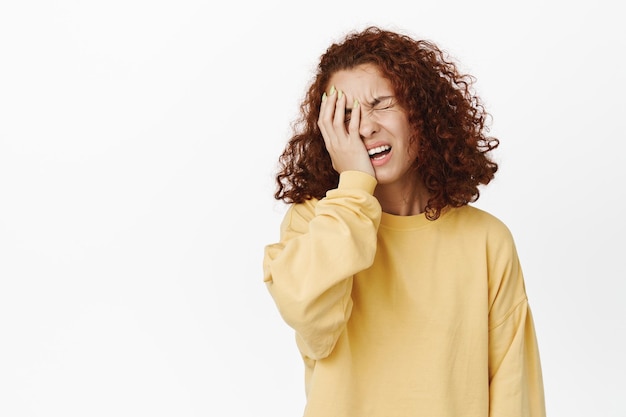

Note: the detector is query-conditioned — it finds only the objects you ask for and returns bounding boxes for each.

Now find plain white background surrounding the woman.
[0,0,626,417]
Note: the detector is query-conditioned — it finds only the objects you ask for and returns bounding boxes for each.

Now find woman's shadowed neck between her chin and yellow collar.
[374,178,430,216]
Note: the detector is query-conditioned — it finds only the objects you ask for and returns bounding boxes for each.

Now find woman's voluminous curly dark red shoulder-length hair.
[274,27,499,220]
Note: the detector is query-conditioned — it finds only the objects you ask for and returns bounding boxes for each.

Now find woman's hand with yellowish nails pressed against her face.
[317,87,376,177]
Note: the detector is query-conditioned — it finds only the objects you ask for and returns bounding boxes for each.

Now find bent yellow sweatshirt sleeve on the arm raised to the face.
[263,171,381,359]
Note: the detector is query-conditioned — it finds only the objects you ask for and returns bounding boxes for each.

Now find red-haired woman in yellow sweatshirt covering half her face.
[264,27,545,417]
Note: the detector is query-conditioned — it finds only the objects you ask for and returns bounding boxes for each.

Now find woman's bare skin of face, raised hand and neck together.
[318,64,430,216]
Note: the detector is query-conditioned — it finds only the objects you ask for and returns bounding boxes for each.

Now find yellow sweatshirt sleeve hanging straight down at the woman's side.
[489,224,546,417]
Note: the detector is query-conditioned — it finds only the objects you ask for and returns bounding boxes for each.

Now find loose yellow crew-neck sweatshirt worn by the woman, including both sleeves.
[263,171,545,417]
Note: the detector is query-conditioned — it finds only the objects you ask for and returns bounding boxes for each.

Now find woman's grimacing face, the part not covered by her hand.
[329,64,417,187]
